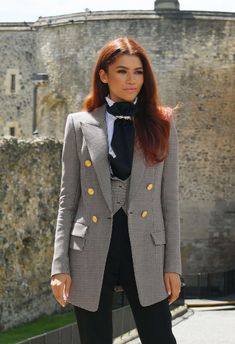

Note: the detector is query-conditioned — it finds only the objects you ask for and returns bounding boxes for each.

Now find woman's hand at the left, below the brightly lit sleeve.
[51,273,72,307]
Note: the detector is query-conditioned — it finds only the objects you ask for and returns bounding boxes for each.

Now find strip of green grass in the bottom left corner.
[0,312,76,344]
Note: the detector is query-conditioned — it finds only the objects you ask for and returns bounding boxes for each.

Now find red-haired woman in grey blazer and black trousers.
[51,37,181,344]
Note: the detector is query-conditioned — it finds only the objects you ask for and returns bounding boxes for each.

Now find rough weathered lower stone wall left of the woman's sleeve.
[0,138,73,329]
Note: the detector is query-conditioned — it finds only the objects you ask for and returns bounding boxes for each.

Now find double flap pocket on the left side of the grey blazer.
[69,222,88,251]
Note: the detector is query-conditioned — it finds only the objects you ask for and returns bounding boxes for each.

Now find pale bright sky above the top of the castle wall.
[0,0,235,22]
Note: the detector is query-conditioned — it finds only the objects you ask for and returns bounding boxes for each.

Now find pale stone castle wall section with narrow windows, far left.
[0,23,36,137]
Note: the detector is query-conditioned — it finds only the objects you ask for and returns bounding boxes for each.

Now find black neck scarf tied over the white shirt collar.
[107,102,137,180]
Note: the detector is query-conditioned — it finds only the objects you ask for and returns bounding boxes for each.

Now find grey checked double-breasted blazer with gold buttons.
[51,105,181,311]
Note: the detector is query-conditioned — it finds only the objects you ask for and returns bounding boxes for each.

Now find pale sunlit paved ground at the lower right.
[129,298,235,344]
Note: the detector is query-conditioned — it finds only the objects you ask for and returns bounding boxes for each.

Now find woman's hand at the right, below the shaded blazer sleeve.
[164,272,181,304]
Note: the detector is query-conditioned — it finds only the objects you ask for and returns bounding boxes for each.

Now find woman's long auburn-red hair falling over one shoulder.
[83,37,178,165]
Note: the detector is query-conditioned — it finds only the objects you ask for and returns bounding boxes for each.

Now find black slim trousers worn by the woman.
[74,208,176,344]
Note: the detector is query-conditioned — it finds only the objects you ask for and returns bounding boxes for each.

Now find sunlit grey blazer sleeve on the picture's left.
[51,114,81,276]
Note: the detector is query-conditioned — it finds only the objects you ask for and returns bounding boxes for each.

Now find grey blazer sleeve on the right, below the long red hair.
[162,117,182,275]
